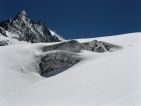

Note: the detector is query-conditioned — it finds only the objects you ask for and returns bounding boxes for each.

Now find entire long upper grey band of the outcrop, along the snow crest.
[41,40,118,53]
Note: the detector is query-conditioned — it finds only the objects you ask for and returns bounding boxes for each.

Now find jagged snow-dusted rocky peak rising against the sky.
[0,11,60,43]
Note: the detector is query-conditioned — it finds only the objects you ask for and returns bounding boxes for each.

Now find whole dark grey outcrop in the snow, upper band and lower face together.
[39,40,120,77]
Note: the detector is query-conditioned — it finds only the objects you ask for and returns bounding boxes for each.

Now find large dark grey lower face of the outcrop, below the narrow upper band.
[39,51,82,77]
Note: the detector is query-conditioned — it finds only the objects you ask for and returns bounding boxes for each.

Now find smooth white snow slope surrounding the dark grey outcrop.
[0,33,141,106]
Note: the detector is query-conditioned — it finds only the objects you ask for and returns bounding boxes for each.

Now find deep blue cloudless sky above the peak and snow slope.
[0,0,141,39]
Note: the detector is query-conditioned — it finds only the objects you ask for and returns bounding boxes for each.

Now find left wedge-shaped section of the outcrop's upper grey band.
[42,40,85,52]
